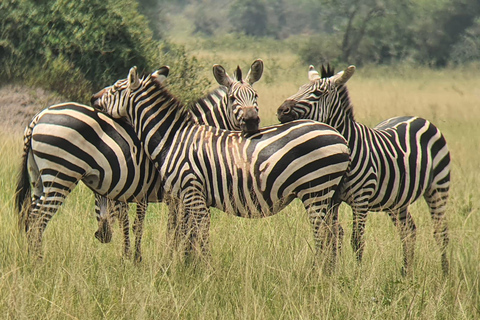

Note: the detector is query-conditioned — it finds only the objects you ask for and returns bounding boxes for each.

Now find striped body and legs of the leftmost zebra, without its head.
[16,103,162,256]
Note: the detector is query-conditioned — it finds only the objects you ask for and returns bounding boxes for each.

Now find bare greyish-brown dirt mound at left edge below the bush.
[0,85,65,135]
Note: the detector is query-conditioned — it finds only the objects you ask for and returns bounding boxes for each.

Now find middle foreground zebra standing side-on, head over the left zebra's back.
[93,67,350,268]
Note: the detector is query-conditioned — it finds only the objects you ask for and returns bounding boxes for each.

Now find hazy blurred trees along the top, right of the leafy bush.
[168,0,480,67]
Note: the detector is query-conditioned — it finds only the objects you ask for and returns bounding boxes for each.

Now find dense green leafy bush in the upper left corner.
[0,0,160,101]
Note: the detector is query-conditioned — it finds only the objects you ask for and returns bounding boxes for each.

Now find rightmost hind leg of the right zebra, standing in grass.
[424,188,449,274]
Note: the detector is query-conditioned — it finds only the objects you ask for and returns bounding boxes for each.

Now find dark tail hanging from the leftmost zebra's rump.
[15,141,32,231]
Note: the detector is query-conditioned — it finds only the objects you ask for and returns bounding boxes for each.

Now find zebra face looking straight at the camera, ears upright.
[213,59,263,133]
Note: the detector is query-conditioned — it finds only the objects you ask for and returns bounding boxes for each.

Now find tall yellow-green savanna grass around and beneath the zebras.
[0,44,480,319]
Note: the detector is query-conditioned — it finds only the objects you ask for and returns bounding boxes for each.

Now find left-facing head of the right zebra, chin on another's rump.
[277,66,355,125]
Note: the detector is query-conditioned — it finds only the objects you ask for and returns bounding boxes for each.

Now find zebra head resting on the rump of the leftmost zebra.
[90,66,170,123]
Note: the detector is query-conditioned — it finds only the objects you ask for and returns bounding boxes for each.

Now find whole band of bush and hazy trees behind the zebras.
[0,0,480,101]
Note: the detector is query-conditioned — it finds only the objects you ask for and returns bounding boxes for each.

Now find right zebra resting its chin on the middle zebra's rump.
[277,66,450,274]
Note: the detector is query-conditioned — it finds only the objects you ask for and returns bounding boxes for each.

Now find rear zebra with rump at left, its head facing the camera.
[16,59,263,261]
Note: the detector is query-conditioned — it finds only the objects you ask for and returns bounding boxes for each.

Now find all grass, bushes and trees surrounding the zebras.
[0,0,480,319]
